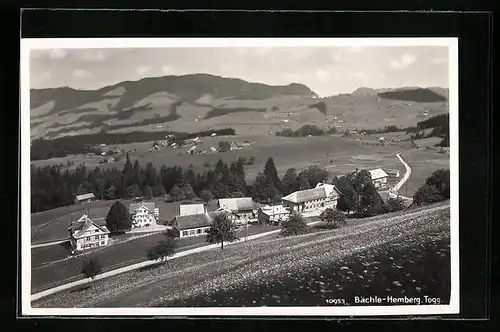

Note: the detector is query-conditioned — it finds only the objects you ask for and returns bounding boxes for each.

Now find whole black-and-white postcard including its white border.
[20,38,460,316]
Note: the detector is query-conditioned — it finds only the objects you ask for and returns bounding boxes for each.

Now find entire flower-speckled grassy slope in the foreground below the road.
[32,203,450,307]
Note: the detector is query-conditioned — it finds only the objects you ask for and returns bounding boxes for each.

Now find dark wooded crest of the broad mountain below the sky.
[30,74,317,113]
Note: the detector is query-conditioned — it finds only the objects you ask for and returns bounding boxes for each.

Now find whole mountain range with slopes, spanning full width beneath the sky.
[30,74,448,148]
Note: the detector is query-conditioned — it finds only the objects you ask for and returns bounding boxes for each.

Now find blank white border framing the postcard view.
[18,38,460,316]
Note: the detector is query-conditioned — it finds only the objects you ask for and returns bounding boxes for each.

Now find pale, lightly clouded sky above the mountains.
[30,46,448,97]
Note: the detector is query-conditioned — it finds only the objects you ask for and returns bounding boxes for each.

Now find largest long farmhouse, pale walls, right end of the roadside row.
[281,183,340,212]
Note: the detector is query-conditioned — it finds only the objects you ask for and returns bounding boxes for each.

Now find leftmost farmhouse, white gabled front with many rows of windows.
[68,214,109,251]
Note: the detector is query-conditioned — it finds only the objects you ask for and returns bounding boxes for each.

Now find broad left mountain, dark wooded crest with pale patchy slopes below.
[30,74,316,138]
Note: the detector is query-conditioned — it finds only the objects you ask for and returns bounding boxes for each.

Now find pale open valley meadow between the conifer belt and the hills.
[31,135,449,193]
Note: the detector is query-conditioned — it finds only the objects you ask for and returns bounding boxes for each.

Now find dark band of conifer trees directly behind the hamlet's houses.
[31,150,328,213]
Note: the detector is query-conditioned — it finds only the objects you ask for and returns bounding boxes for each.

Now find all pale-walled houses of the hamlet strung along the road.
[68,168,399,250]
